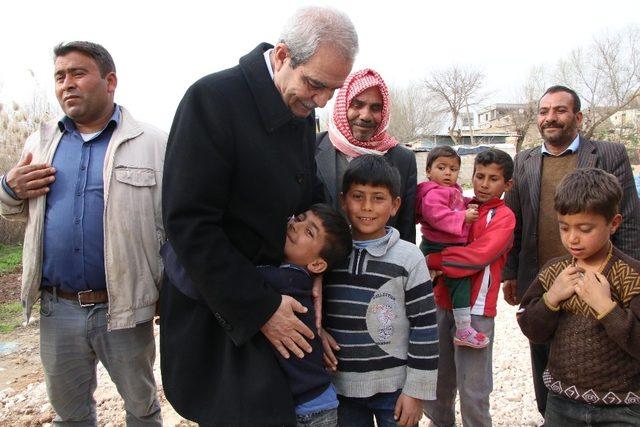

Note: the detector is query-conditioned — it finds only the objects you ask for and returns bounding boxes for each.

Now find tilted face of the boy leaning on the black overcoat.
[284,210,327,273]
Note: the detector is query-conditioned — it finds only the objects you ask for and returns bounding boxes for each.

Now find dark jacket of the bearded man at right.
[503,136,640,299]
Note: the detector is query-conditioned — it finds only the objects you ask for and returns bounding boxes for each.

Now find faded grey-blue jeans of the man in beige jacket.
[40,291,162,426]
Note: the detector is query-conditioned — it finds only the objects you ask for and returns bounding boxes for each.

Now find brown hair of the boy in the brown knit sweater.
[553,168,622,221]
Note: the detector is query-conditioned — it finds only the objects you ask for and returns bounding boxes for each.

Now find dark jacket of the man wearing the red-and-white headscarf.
[316,132,417,243]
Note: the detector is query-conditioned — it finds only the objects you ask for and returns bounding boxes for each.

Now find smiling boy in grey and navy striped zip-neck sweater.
[323,155,438,427]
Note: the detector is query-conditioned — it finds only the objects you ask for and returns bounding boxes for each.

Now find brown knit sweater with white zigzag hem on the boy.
[518,248,640,405]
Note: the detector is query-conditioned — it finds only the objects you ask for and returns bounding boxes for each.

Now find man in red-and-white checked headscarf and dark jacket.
[316,68,417,243]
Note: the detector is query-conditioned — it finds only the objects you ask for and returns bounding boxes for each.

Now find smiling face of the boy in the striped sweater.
[340,184,400,240]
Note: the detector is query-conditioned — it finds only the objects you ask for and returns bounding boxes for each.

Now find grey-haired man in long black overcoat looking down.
[160,8,358,426]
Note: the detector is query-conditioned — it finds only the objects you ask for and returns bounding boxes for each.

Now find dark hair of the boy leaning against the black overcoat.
[309,203,353,270]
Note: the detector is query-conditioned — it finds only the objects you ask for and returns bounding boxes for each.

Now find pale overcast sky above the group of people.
[0,0,640,131]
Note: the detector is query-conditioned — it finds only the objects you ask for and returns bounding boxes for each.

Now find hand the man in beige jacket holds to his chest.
[5,153,56,200]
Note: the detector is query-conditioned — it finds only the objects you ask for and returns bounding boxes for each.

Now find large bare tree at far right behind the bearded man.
[556,25,640,138]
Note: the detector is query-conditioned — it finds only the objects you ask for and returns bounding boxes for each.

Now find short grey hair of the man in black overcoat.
[278,6,358,68]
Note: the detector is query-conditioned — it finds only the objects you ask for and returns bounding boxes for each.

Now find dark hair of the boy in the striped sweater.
[342,154,400,198]
